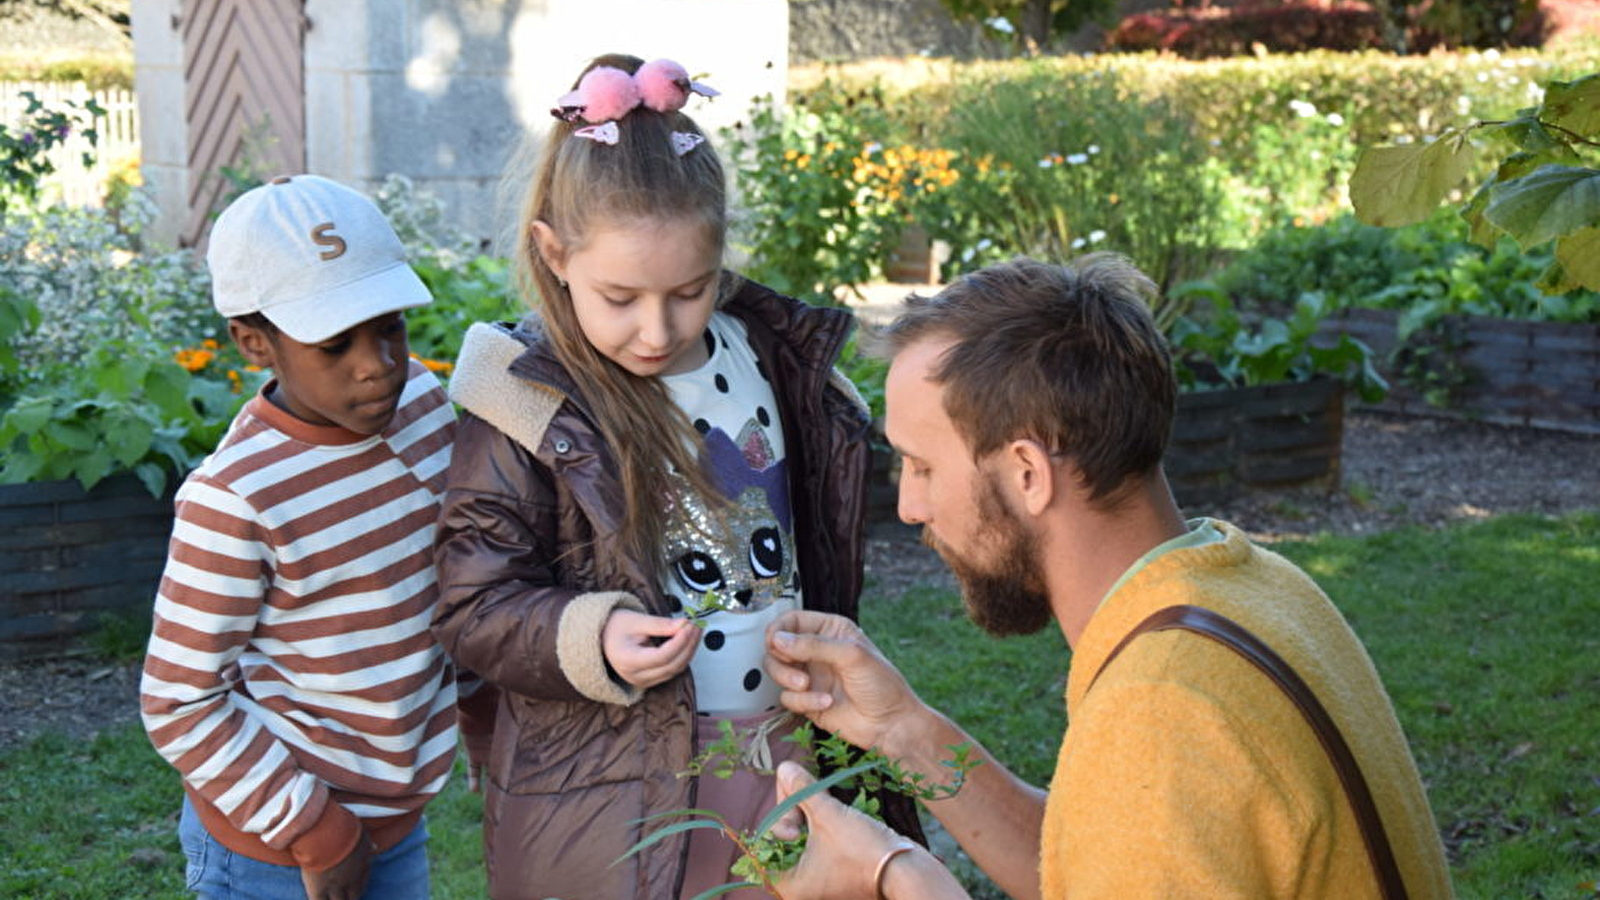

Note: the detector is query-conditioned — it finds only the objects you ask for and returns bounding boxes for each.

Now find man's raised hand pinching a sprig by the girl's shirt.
[766,610,925,757]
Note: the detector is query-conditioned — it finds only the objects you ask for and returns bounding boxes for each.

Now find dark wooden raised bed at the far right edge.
[1322,309,1600,434]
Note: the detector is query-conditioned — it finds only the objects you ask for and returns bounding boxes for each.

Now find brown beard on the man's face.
[922,477,1053,637]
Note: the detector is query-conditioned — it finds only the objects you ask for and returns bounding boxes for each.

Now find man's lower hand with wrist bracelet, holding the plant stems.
[773,762,966,900]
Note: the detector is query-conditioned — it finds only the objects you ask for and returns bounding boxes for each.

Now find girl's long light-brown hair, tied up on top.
[514,54,733,570]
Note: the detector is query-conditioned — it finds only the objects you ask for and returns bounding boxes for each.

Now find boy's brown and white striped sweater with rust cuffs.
[139,362,456,871]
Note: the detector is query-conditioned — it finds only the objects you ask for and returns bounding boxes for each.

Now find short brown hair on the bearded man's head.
[882,253,1178,506]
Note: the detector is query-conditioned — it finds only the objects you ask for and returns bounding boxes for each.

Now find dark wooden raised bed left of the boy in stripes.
[0,476,173,658]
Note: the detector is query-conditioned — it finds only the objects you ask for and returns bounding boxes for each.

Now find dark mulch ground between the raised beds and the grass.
[0,412,1600,753]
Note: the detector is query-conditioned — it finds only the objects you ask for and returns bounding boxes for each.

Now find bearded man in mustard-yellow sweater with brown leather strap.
[768,255,1451,900]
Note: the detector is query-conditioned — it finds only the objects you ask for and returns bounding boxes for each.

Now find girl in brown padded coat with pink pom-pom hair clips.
[434,56,917,900]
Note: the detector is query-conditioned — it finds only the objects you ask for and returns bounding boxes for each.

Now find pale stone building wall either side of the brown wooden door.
[134,0,789,245]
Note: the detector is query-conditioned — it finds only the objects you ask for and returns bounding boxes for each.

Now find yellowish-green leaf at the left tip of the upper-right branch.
[1350,131,1474,227]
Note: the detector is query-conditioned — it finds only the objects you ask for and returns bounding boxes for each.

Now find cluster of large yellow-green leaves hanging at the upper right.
[1350,74,1600,293]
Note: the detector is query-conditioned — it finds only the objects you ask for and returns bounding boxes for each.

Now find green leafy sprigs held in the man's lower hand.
[621,714,981,900]
